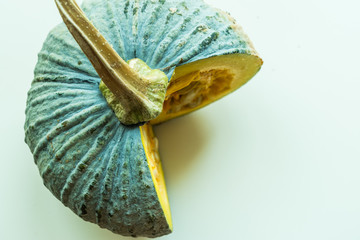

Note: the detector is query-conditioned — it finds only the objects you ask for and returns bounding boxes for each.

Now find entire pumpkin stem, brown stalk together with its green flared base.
[55,0,168,125]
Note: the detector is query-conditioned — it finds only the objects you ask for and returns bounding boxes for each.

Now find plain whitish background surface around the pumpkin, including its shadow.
[0,0,360,240]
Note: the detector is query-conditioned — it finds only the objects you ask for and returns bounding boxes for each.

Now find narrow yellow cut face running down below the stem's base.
[139,123,173,231]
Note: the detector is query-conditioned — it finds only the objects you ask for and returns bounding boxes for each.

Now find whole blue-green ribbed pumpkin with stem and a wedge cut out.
[25,0,262,237]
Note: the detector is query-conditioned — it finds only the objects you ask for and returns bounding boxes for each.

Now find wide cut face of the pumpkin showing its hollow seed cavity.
[151,54,262,124]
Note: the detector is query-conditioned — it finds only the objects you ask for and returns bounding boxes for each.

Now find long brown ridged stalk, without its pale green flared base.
[55,0,167,124]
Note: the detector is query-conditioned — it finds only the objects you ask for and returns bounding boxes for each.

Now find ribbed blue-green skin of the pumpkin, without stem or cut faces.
[25,0,261,237]
